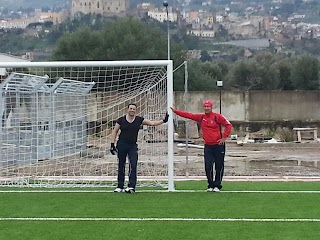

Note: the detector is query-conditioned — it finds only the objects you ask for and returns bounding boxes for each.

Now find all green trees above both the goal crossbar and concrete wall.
[52,15,320,91]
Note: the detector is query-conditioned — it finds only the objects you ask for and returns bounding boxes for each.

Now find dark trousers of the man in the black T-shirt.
[117,142,138,188]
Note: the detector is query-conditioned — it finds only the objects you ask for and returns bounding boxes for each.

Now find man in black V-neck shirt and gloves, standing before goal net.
[110,103,169,193]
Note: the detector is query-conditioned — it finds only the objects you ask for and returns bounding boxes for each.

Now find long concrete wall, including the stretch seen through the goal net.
[6,91,320,122]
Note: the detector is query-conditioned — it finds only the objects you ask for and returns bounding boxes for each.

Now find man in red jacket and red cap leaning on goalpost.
[171,100,232,192]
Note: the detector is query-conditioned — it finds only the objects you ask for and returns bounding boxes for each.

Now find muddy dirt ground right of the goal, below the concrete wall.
[174,142,320,179]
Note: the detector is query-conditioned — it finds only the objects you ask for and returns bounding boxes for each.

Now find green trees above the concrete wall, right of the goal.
[192,52,320,91]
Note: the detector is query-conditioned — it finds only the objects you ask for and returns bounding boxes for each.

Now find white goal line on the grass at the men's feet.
[0,190,320,194]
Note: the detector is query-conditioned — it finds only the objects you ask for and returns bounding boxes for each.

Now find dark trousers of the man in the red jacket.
[204,144,226,189]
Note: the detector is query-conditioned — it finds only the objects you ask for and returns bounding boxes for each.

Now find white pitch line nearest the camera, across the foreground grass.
[0,218,320,222]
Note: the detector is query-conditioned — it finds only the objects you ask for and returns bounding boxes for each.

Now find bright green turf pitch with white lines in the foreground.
[0,181,320,240]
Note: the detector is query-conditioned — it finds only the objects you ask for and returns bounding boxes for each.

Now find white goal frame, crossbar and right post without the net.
[0,60,175,191]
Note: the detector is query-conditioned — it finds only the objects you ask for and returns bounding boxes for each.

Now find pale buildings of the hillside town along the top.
[0,0,320,39]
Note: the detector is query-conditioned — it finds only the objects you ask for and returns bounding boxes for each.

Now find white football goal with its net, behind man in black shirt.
[0,61,173,190]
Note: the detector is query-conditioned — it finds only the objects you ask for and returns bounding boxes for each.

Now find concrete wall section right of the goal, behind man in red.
[175,91,320,122]
